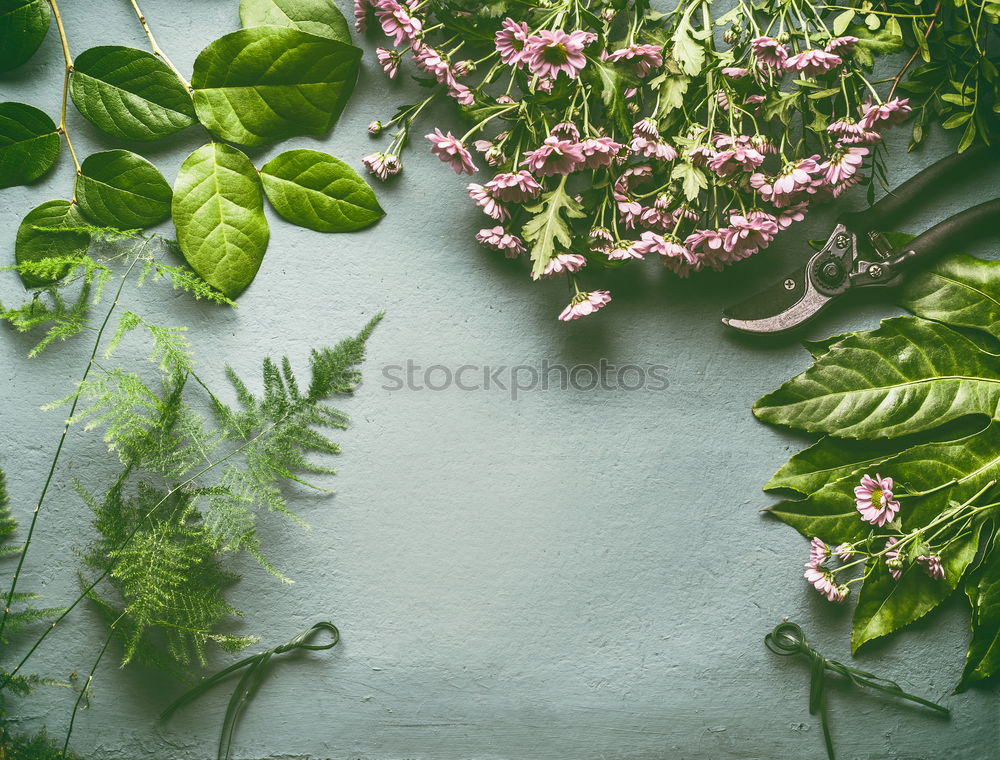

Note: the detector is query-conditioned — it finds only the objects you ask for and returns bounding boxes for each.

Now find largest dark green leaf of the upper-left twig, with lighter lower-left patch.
[191,26,361,145]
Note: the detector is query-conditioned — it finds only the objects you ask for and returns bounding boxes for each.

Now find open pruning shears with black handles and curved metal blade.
[722,148,1000,334]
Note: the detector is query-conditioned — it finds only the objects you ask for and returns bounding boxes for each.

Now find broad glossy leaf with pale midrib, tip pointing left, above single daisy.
[754,317,1000,438]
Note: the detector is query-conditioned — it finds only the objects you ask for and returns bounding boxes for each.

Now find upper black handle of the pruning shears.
[841,145,1000,232]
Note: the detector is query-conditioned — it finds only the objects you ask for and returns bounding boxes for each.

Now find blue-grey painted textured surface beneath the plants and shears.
[0,0,1000,760]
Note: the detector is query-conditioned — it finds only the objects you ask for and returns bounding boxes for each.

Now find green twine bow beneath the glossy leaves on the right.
[764,622,951,760]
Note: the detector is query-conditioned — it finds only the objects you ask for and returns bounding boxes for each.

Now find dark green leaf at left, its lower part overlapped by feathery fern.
[14,201,90,288]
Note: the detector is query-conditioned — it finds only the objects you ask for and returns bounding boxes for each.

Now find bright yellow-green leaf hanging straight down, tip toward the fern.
[173,143,270,298]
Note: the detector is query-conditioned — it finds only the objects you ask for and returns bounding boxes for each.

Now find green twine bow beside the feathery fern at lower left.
[160,621,340,760]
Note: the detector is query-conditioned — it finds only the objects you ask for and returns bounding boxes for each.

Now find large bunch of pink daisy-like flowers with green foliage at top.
[364,0,910,320]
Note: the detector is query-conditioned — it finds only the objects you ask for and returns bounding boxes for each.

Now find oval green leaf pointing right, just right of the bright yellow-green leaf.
[260,150,385,232]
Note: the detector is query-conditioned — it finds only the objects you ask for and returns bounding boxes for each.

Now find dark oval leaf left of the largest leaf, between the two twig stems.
[70,45,196,141]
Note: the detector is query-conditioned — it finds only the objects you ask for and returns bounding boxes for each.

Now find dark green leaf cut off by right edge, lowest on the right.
[956,541,1000,691]
